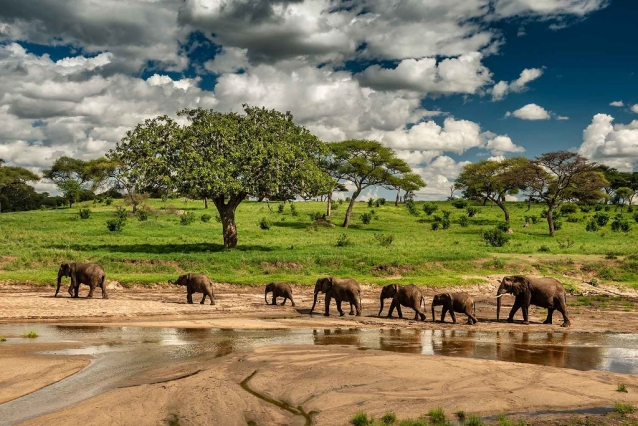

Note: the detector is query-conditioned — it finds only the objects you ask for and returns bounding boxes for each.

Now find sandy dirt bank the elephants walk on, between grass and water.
[0,284,638,332]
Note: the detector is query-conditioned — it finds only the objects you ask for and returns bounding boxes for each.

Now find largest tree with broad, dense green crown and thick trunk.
[109,105,330,247]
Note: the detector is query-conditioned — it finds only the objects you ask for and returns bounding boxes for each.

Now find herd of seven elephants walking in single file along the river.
[55,263,570,327]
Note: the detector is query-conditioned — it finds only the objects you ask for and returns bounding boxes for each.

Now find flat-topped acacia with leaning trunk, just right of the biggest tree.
[328,140,420,228]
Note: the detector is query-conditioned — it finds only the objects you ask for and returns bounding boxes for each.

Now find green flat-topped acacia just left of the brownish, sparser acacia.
[454,157,529,223]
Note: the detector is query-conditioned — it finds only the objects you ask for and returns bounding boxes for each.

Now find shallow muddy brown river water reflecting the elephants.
[0,324,638,424]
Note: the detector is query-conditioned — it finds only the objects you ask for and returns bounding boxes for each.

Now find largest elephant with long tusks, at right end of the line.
[496,275,571,327]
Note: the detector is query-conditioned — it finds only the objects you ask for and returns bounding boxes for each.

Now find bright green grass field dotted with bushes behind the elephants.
[0,200,638,288]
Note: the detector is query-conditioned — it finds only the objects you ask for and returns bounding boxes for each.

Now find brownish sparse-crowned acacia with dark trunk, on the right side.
[517,151,608,236]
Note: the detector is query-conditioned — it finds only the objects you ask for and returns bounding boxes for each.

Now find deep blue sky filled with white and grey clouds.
[0,0,638,198]
